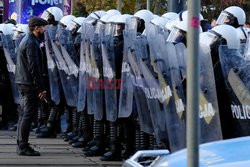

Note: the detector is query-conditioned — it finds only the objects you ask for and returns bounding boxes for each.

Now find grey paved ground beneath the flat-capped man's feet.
[0,131,122,167]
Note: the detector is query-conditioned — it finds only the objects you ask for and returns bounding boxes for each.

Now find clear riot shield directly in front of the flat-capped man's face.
[45,28,60,105]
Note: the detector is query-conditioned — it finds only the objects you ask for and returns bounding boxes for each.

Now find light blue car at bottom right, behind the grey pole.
[123,137,250,167]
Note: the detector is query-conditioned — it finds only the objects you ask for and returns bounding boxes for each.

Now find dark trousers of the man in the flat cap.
[17,85,38,149]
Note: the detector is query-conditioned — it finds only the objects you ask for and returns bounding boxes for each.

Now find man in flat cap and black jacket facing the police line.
[15,17,47,156]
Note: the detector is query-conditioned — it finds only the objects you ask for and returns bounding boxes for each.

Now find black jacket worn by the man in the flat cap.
[15,33,45,92]
